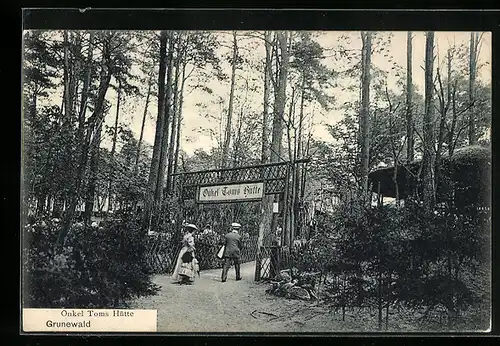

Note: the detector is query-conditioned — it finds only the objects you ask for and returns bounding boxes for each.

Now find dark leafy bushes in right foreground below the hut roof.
[293,201,491,330]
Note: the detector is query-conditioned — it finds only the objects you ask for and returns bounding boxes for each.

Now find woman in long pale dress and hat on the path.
[172,224,199,284]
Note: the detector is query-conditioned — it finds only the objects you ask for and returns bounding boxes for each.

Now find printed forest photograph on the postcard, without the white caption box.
[21,30,492,333]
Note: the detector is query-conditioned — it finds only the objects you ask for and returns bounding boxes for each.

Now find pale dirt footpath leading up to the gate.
[131,262,346,332]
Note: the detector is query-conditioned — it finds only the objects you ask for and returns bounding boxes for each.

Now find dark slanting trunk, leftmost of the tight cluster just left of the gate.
[144,31,168,232]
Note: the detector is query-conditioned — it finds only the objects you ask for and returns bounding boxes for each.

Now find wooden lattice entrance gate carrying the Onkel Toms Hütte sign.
[167,160,307,281]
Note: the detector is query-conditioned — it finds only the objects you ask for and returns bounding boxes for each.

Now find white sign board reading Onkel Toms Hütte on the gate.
[196,182,264,203]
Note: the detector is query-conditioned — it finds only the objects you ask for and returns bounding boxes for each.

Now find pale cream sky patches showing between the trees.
[36,31,491,154]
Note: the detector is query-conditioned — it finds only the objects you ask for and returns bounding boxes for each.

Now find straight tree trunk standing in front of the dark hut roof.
[422,31,435,210]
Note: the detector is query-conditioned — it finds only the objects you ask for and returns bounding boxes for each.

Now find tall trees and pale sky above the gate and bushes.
[23,31,491,235]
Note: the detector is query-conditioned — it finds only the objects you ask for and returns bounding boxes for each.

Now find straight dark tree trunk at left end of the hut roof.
[360,32,372,200]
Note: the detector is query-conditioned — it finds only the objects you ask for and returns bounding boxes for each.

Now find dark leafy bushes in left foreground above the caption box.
[23,220,158,308]
